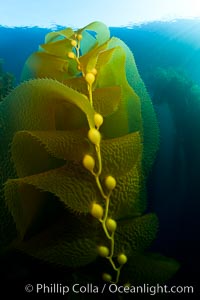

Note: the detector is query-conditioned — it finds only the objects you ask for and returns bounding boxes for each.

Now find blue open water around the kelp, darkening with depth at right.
[0,20,200,296]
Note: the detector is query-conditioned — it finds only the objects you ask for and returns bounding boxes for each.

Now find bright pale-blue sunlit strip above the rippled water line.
[0,0,200,27]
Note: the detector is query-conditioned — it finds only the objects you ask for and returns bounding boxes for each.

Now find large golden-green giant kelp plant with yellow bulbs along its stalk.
[0,22,178,284]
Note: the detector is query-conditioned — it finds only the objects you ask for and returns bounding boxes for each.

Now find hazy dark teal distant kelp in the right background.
[147,67,200,237]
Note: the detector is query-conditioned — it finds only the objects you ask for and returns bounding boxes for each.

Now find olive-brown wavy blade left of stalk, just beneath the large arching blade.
[11,130,90,177]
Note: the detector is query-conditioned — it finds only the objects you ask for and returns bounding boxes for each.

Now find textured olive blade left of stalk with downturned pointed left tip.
[5,162,99,230]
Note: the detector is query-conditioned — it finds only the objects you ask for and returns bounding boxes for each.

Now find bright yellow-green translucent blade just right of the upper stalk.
[95,38,142,138]
